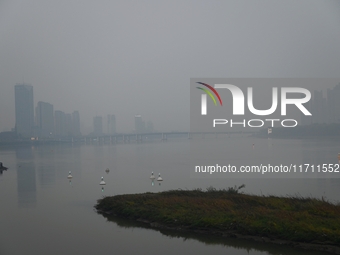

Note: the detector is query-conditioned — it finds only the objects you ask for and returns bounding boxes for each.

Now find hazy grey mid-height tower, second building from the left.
[35,101,54,137]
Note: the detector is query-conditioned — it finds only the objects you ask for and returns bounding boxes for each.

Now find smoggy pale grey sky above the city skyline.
[0,0,340,134]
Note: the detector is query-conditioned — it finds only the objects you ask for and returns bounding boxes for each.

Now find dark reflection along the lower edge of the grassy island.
[100,215,320,255]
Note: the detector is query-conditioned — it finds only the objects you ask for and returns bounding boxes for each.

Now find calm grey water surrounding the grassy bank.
[0,137,340,255]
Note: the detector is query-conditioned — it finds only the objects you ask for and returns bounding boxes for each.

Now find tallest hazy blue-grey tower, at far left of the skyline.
[14,84,34,138]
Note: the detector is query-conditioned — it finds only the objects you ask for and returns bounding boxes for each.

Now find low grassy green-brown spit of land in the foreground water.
[95,186,340,254]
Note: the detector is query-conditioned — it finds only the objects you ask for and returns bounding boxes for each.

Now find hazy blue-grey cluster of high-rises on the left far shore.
[10,83,158,139]
